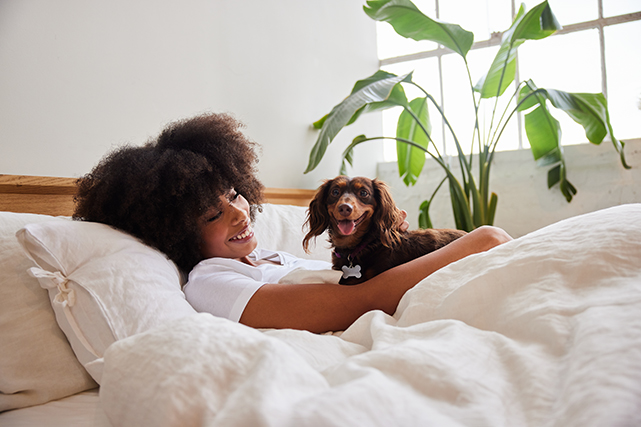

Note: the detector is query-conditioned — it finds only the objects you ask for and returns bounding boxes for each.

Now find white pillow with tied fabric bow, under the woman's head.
[16,221,196,383]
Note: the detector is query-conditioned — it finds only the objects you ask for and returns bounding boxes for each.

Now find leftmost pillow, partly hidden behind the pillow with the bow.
[0,212,97,412]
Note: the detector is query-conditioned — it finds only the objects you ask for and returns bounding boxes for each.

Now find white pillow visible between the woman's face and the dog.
[254,203,332,262]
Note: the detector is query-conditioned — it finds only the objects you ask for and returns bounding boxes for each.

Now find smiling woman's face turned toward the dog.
[200,189,258,259]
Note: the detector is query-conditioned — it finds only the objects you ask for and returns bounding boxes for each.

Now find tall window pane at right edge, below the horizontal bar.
[605,21,641,139]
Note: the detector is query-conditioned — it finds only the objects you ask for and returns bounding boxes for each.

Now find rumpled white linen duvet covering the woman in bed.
[100,205,641,427]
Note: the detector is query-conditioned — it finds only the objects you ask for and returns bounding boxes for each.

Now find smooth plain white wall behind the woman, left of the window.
[0,0,382,188]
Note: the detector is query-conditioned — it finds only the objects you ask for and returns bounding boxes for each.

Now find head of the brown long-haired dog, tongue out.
[303,176,402,250]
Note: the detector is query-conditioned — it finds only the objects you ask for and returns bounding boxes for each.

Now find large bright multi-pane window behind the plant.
[377,0,641,161]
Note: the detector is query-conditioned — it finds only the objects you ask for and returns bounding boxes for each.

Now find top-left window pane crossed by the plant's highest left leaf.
[376,0,438,59]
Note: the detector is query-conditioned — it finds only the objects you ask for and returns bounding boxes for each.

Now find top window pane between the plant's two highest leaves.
[439,0,512,41]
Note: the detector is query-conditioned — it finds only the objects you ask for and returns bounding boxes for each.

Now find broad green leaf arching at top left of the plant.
[363,0,474,58]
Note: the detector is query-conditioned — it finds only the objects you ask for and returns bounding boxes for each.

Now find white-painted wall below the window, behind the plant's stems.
[378,139,641,237]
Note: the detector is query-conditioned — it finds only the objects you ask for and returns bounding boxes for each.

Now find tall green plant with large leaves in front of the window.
[305,0,629,231]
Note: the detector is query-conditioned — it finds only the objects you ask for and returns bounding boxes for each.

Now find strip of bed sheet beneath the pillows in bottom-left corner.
[0,388,111,427]
